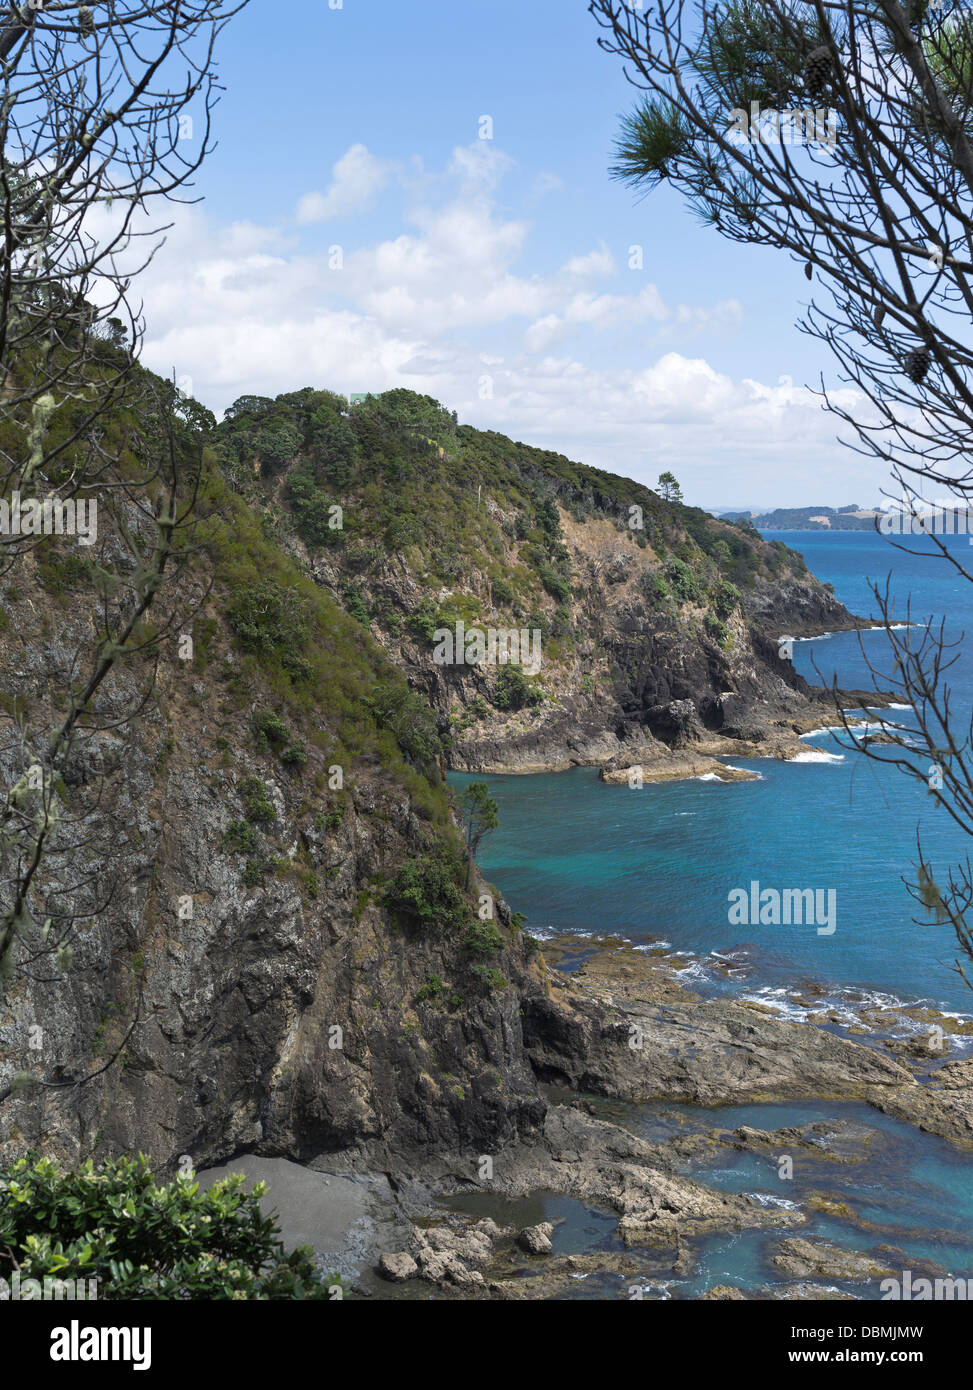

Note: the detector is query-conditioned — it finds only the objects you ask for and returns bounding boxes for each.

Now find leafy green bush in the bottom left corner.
[0,1155,329,1301]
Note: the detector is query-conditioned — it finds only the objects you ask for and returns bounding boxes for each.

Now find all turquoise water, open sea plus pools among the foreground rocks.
[450,532,973,1298]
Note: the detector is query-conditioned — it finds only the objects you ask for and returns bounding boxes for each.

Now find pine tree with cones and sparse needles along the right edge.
[589,0,973,978]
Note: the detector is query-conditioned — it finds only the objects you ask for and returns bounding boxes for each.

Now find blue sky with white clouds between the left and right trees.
[138,0,884,509]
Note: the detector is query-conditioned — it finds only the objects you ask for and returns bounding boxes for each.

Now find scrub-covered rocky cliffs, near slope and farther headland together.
[0,380,872,1172]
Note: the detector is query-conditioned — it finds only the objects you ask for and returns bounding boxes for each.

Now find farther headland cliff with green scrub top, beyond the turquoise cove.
[217,391,856,771]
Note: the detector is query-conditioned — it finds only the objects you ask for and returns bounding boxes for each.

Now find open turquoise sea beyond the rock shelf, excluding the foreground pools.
[452,532,973,1013]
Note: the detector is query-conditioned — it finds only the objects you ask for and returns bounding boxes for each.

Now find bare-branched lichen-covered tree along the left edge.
[0,0,242,1102]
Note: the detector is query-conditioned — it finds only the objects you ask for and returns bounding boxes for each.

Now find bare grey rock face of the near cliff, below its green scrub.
[0,581,546,1172]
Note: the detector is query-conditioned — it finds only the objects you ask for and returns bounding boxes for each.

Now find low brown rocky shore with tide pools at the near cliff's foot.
[243,937,973,1300]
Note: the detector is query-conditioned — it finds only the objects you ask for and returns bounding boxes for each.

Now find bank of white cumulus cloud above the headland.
[138,142,876,506]
